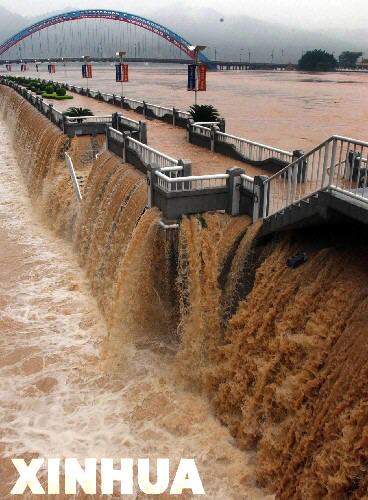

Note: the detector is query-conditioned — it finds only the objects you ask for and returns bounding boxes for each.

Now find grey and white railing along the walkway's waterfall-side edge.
[0,78,258,220]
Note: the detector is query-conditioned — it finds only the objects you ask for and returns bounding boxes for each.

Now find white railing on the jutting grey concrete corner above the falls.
[155,170,229,193]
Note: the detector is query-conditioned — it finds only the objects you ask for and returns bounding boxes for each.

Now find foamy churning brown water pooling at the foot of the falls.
[0,115,265,500]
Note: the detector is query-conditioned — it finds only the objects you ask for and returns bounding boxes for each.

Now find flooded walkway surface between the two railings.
[45,93,267,176]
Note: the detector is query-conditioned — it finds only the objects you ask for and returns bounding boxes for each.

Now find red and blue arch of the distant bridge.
[0,9,211,65]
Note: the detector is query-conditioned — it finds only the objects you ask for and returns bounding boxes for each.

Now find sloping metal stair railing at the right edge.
[263,135,368,217]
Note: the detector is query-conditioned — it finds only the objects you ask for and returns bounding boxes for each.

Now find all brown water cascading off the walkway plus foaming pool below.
[0,82,368,500]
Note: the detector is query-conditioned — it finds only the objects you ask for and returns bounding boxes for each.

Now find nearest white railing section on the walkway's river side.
[216,132,293,163]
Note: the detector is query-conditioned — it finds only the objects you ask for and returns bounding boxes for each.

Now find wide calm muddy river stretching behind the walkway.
[15,64,368,151]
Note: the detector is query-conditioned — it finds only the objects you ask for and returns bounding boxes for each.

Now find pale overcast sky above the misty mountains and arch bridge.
[0,0,368,29]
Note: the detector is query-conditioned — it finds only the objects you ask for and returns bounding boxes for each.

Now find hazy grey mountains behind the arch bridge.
[0,5,368,63]
